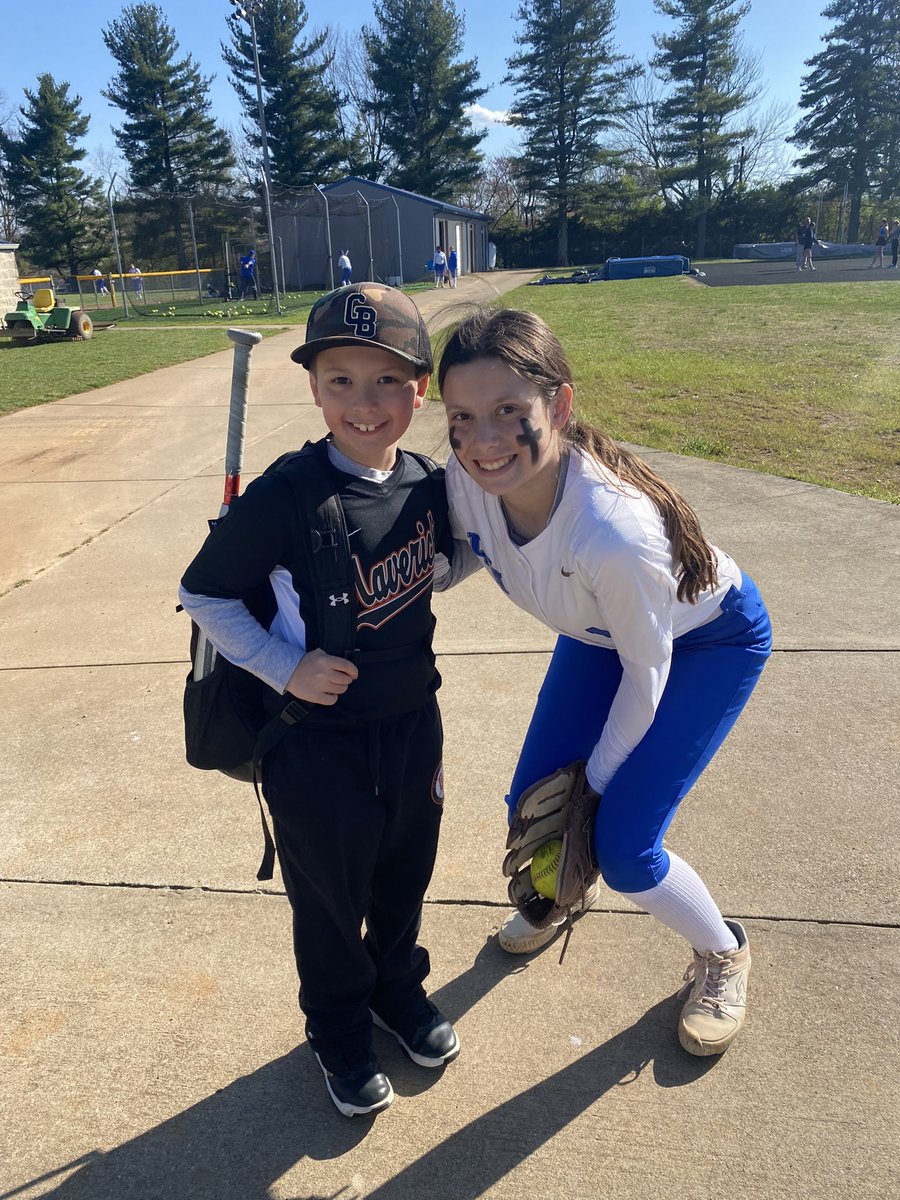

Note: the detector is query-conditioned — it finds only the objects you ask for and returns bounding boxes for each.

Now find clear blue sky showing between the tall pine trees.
[0,0,829,166]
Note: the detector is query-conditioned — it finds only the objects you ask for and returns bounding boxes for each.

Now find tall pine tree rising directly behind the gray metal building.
[362,0,487,202]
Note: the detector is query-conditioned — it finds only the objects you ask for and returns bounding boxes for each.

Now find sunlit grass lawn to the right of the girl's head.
[465,277,900,503]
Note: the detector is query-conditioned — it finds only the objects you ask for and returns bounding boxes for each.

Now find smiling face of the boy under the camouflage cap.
[310,346,428,470]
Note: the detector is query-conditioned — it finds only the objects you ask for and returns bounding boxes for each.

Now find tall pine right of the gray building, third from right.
[508,0,637,266]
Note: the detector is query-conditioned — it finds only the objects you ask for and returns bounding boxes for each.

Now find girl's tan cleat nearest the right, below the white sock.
[678,920,750,1056]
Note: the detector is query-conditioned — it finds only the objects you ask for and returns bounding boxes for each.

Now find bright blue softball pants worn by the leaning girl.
[506,575,772,892]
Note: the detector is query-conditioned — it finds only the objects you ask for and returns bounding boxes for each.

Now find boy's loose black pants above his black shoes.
[263,697,443,1074]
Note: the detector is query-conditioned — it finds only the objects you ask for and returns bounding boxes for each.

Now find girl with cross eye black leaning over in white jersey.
[438,310,772,1055]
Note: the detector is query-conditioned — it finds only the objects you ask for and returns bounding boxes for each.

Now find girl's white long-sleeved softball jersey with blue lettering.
[446,449,742,792]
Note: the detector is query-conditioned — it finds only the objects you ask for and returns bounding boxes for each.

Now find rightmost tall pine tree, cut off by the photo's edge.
[788,0,900,241]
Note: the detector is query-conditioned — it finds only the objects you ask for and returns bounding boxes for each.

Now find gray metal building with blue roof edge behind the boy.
[274,175,490,292]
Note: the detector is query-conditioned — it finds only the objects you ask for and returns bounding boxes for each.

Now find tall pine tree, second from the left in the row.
[103,4,234,265]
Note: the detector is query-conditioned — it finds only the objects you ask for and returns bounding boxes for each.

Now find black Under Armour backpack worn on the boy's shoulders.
[184,442,437,880]
